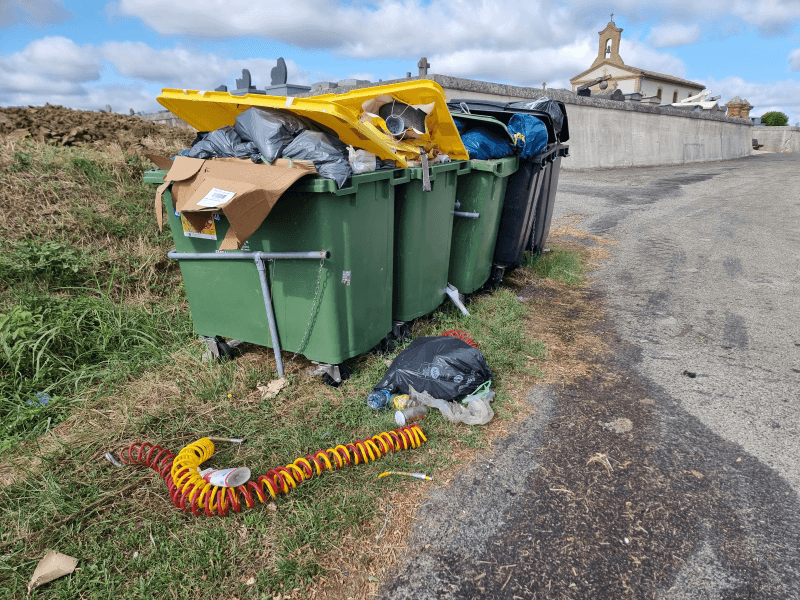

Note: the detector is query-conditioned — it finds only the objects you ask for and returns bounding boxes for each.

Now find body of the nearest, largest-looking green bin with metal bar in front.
[145,170,408,365]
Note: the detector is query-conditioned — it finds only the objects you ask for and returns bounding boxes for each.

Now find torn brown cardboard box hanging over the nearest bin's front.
[148,155,316,250]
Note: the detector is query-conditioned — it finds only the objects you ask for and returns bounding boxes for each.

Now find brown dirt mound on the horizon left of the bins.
[0,104,195,148]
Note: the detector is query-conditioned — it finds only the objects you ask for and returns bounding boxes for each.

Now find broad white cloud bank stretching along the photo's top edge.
[112,0,800,51]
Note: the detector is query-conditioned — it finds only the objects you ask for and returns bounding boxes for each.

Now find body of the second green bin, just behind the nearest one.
[394,161,470,321]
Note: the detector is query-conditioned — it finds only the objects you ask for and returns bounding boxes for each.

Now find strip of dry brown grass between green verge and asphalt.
[311,216,617,600]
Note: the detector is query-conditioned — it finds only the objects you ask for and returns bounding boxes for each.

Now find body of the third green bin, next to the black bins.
[449,156,519,294]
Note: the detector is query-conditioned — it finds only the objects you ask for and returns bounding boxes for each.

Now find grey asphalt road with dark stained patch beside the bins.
[381,154,800,600]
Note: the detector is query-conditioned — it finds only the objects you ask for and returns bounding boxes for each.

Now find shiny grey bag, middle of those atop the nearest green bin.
[233,107,310,163]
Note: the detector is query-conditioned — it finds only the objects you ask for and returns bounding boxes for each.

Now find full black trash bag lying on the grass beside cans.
[373,336,492,400]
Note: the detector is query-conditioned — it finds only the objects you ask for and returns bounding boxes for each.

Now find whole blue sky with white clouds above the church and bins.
[0,0,800,123]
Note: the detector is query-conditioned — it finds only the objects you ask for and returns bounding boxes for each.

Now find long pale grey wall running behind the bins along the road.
[308,75,760,169]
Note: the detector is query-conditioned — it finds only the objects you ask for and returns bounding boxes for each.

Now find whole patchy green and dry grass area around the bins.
[0,131,600,599]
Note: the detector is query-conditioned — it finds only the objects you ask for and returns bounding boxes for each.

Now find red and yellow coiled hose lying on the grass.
[119,424,427,517]
